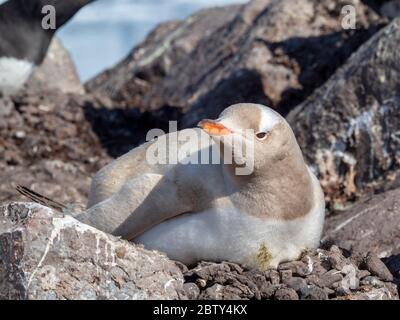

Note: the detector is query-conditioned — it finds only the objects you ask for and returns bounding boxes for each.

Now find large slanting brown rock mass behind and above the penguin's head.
[86,0,383,127]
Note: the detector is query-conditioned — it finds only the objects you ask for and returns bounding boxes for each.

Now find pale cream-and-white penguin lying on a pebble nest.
[77,104,325,269]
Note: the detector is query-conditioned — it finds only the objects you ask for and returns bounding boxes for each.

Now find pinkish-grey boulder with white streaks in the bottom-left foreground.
[0,203,188,300]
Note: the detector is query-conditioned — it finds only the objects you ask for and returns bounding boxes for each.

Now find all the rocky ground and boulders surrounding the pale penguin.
[0,0,400,299]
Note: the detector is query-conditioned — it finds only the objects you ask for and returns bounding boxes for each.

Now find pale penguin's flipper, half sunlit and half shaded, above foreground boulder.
[76,173,192,240]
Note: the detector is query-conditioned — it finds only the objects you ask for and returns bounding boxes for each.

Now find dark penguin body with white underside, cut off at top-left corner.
[0,0,94,95]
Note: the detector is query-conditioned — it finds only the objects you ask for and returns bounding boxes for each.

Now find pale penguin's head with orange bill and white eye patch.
[198,103,301,173]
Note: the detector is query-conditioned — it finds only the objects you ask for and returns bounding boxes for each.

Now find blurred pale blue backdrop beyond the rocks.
[55,0,247,81]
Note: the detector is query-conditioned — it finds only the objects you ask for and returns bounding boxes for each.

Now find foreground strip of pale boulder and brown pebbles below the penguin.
[0,203,400,300]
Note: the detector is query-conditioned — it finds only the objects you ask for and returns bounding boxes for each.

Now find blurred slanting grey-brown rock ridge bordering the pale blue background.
[86,6,240,106]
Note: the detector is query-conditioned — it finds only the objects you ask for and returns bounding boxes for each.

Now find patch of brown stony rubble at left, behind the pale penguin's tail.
[0,91,112,208]
